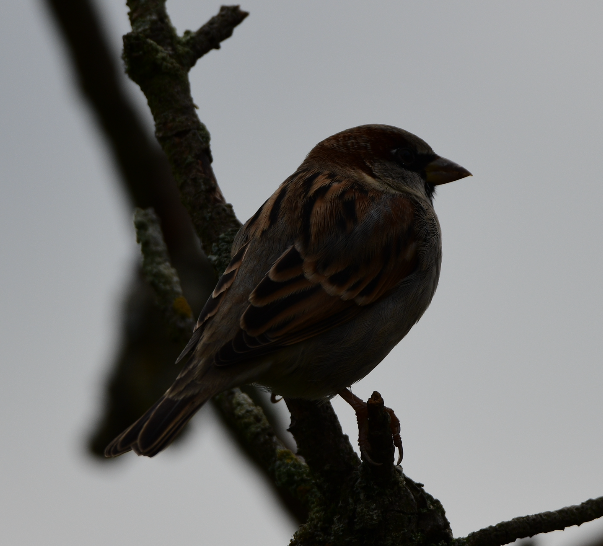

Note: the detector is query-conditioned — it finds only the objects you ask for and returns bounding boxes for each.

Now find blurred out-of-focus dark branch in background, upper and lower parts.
[45,0,216,460]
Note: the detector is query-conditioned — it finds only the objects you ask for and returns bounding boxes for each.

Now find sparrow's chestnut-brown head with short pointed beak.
[304,125,471,200]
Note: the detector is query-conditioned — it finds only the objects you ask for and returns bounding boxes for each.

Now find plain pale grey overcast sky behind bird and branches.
[0,0,603,546]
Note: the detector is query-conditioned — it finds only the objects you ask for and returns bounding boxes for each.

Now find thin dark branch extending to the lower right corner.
[455,497,603,546]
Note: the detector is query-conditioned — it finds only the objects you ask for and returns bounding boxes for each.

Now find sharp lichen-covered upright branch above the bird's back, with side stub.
[123,0,245,256]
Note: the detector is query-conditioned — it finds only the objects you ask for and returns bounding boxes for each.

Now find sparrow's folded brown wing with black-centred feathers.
[199,173,419,366]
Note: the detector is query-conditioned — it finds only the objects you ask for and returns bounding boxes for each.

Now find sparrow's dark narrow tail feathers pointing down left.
[105,393,208,457]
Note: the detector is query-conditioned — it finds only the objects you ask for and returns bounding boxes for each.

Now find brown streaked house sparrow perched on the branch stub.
[105,125,471,457]
